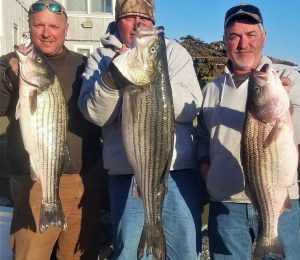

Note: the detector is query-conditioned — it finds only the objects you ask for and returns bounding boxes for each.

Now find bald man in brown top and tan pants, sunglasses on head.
[0,0,103,260]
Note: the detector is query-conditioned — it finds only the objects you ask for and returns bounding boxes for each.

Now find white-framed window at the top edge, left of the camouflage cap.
[66,0,112,14]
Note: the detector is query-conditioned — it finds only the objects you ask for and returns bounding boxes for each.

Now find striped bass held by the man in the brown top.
[15,45,69,232]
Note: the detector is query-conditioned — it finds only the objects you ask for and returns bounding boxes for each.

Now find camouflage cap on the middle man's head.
[115,0,155,22]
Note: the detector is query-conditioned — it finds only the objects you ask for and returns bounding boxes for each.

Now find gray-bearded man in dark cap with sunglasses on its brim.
[198,4,300,260]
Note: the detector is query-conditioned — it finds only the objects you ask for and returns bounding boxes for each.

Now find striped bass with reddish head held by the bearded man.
[242,64,298,258]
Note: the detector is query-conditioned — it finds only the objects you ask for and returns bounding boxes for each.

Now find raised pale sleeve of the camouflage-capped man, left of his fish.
[78,48,121,126]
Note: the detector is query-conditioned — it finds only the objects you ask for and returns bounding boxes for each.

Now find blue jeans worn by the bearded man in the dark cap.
[208,200,300,260]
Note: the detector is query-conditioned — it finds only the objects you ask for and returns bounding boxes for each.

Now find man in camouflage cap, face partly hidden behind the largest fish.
[78,0,206,260]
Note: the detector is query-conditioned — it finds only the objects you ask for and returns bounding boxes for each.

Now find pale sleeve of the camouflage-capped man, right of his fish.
[166,40,202,123]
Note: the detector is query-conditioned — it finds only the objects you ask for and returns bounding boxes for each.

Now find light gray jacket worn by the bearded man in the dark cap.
[197,56,300,203]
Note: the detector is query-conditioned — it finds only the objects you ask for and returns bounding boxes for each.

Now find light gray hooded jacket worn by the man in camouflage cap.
[78,24,202,175]
